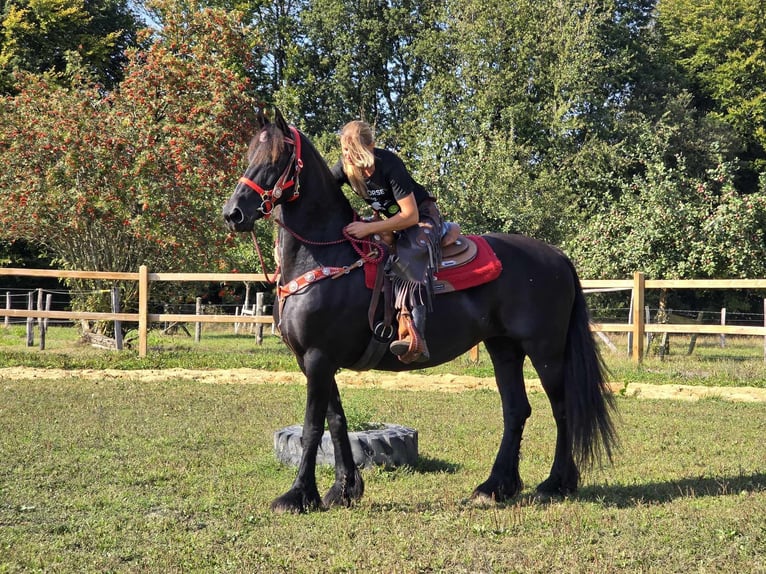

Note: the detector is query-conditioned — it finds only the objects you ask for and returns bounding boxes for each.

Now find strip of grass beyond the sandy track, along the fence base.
[0,326,766,388]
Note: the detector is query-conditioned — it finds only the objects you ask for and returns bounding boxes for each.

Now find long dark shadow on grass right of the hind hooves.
[577,473,766,508]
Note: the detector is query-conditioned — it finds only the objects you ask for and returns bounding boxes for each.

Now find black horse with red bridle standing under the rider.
[223,110,616,512]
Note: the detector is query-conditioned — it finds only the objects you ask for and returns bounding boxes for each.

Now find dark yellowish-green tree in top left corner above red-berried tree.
[0,0,138,93]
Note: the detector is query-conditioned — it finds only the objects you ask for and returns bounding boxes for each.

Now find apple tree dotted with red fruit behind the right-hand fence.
[566,104,766,279]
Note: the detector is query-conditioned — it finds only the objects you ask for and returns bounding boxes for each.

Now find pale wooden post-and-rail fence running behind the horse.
[0,265,766,363]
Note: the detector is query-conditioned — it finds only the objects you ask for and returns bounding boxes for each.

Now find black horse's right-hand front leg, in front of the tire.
[322,378,364,507]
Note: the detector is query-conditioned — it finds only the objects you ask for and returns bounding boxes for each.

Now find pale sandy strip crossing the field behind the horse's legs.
[0,367,766,402]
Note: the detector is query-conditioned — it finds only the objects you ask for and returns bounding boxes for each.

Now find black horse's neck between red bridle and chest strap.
[279,139,354,280]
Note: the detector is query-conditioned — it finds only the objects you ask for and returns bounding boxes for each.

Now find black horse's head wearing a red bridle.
[223,109,303,231]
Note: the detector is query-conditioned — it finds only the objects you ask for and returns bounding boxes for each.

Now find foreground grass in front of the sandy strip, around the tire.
[0,374,766,573]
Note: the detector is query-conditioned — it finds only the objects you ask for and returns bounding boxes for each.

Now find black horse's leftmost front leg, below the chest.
[271,357,334,513]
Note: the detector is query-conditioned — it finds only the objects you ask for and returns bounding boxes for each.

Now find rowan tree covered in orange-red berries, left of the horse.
[0,2,262,312]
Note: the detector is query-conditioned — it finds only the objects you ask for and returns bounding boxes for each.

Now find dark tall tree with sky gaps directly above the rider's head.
[271,0,438,141]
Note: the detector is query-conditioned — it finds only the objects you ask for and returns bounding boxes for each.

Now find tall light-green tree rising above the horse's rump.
[409,0,629,242]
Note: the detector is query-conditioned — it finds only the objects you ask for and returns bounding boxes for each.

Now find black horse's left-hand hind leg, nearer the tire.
[471,338,532,503]
